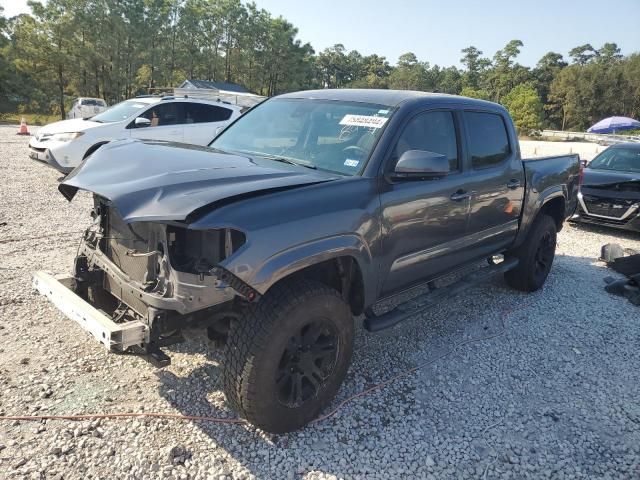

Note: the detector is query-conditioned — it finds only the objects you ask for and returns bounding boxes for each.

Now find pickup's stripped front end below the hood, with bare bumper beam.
[34,195,259,365]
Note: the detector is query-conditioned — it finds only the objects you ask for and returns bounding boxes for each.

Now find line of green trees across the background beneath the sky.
[0,0,640,133]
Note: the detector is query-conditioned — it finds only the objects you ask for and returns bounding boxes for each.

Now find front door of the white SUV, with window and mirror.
[128,101,184,142]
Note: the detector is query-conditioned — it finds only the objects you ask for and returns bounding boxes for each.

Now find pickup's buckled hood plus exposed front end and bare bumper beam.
[34,139,335,361]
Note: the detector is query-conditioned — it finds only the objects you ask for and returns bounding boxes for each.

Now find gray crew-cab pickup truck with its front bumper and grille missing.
[34,90,580,432]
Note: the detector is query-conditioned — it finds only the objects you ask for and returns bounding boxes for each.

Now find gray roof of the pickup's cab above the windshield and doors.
[278,88,502,108]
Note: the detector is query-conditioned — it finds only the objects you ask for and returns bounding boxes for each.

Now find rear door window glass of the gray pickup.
[464,112,511,169]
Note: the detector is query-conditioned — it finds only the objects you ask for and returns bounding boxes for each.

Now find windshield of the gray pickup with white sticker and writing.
[209,98,392,175]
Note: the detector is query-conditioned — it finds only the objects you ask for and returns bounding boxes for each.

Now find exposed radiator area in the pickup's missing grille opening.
[104,208,157,284]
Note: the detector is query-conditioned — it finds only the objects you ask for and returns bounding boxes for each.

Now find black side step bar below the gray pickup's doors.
[364,258,518,332]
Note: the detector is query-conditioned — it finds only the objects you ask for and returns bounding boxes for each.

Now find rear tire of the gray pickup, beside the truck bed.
[504,214,557,292]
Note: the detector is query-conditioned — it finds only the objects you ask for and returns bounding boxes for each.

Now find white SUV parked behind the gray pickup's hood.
[29,96,240,173]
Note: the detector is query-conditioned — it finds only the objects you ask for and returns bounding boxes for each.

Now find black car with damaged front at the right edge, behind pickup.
[575,143,640,232]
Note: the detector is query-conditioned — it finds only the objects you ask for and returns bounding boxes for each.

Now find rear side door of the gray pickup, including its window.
[462,110,525,256]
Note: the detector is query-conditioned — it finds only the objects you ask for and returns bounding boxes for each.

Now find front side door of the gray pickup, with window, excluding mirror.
[380,110,470,296]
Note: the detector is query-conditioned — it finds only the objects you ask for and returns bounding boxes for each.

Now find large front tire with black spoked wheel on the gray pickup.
[223,280,354,433]
